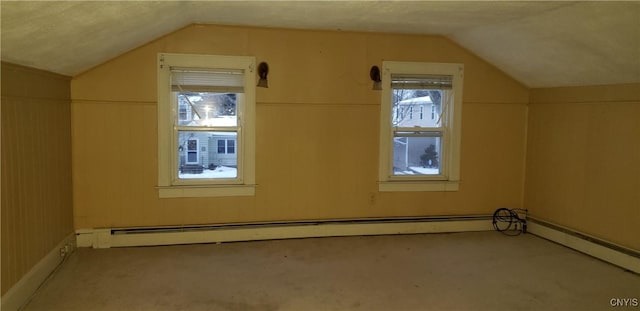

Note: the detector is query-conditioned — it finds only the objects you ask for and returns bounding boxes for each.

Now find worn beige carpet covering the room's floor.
[25,232,640,311]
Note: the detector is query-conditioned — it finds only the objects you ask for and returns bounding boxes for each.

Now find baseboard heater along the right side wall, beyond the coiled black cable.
[527,217,640,273]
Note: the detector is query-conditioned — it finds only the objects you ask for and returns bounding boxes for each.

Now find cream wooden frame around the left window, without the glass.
[157,53,256,198]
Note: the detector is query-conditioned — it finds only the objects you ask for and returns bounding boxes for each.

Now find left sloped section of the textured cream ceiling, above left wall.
[0,1,190,76]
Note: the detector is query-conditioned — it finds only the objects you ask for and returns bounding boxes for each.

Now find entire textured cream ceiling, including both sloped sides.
[1,1,640,87]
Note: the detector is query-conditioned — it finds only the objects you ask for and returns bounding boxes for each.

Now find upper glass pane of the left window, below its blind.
[174,92,238,126]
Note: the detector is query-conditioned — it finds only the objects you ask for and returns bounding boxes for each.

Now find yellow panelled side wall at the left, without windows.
[1,62,73,295]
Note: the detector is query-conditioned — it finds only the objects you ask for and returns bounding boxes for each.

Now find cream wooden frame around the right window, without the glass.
[378,61,464,191]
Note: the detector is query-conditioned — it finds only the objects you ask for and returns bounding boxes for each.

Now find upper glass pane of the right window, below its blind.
[391,89,446,127]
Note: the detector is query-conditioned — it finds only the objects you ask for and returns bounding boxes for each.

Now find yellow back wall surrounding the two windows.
[72,25,529,229]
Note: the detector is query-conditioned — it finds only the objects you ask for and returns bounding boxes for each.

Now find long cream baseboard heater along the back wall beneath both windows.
[76,215,492,248]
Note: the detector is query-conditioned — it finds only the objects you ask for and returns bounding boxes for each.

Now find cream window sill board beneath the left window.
[158,185,256,199]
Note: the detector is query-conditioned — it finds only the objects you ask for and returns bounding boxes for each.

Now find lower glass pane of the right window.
[393,136,442,176]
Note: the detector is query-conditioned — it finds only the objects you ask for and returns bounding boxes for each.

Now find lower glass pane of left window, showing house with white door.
[178,131,238,179]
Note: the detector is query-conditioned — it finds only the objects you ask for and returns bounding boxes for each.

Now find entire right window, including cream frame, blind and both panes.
[379,62,463,191]
